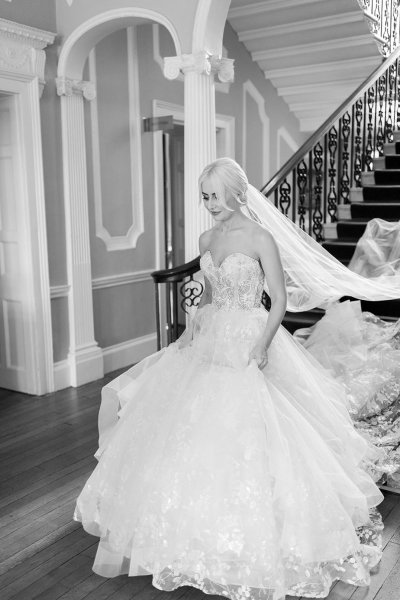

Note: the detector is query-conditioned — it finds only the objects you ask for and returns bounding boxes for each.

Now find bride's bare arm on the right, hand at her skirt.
[255,230,287,350]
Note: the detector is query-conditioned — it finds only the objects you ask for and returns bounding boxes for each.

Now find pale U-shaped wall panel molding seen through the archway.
[89,27,144,252]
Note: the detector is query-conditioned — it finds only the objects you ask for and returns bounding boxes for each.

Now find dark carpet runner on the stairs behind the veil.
[283,132,400,333]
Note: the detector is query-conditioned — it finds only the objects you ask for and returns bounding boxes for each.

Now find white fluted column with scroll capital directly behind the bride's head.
[164,51,233,261]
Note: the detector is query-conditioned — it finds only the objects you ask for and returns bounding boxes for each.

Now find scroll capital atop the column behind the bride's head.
[164,50,234,83]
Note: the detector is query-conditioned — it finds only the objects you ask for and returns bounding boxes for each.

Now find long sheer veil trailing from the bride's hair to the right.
[241,185,400,312]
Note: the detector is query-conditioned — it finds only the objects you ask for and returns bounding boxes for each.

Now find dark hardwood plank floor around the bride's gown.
[0,373,400,600]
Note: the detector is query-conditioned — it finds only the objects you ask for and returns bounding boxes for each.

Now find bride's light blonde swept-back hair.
[199,157,249,210]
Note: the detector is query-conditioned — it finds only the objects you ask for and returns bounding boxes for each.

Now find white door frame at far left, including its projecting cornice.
[0,19,55,395]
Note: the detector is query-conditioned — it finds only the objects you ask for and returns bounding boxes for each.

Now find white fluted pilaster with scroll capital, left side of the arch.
[57,78,104,387]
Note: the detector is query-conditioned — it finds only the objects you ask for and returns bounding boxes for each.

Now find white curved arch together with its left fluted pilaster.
[57,7,181,386]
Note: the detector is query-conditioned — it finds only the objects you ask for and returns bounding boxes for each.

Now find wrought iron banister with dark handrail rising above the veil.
[262,47,400,242]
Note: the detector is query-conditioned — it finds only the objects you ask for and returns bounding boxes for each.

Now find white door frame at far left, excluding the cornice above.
[0,76,54,395]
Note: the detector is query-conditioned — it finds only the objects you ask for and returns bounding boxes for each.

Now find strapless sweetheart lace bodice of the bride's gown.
[200,250,264,310]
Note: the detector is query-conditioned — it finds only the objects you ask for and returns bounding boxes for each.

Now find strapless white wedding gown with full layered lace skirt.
[75,251,382,600]
